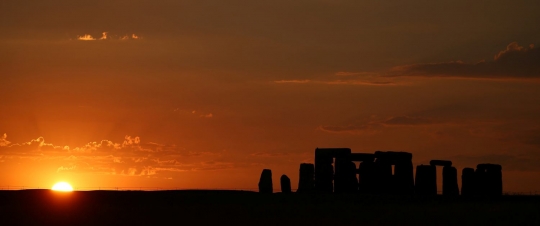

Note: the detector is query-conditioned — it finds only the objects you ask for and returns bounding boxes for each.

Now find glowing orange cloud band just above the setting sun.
[0,134,236,176]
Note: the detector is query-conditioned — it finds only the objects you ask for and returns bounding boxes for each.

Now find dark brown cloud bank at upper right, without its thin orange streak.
[388,42,540,79]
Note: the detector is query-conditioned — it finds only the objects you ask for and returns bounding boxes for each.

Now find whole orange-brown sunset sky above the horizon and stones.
[0,0,540,192]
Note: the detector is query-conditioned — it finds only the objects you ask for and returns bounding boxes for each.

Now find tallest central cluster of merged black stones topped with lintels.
[315,148,414,194]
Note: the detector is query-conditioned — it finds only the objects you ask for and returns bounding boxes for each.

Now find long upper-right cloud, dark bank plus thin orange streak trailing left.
[274,42,540,83]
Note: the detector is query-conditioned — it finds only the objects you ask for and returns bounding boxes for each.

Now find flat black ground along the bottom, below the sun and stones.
[0,190,540,225]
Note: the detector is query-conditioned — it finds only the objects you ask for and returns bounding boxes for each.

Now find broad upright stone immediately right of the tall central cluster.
[414,165,437,195]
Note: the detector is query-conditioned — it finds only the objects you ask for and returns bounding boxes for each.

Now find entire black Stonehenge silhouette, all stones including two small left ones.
[259,148,503,196]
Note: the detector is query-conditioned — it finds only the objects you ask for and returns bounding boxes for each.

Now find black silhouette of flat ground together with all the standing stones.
[0,149,540,225]
